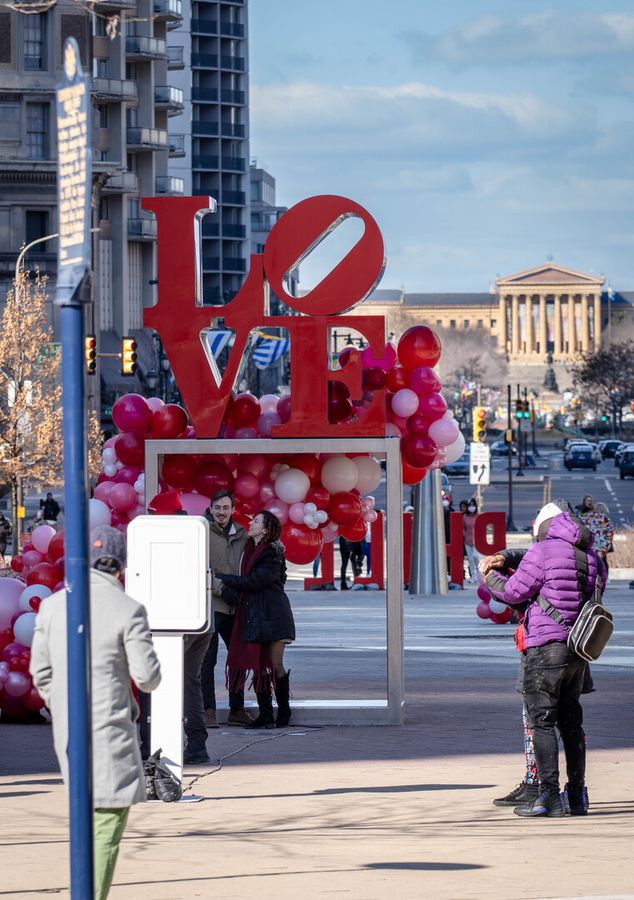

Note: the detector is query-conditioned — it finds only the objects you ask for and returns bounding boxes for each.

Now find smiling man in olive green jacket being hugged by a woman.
[201,491,252,728]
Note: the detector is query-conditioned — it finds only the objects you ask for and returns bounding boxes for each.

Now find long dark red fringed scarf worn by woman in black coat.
[225,538,273,694]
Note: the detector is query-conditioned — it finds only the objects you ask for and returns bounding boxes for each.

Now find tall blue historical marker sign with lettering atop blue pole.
[55,38,92,304]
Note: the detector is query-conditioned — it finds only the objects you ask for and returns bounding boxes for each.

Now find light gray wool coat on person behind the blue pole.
[30,569,161,809]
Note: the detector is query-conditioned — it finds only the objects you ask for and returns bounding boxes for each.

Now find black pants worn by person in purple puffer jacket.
[523,641,586,791]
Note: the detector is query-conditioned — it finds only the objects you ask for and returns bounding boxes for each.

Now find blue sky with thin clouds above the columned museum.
[249,0,634,291]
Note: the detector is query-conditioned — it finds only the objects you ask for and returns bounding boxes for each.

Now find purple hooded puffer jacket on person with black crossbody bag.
[487,512,605,647]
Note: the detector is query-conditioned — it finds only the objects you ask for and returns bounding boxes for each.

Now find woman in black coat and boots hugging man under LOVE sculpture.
[214,509,295,728]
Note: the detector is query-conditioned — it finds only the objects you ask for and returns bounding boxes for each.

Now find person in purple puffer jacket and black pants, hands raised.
[486,501,605,817]
